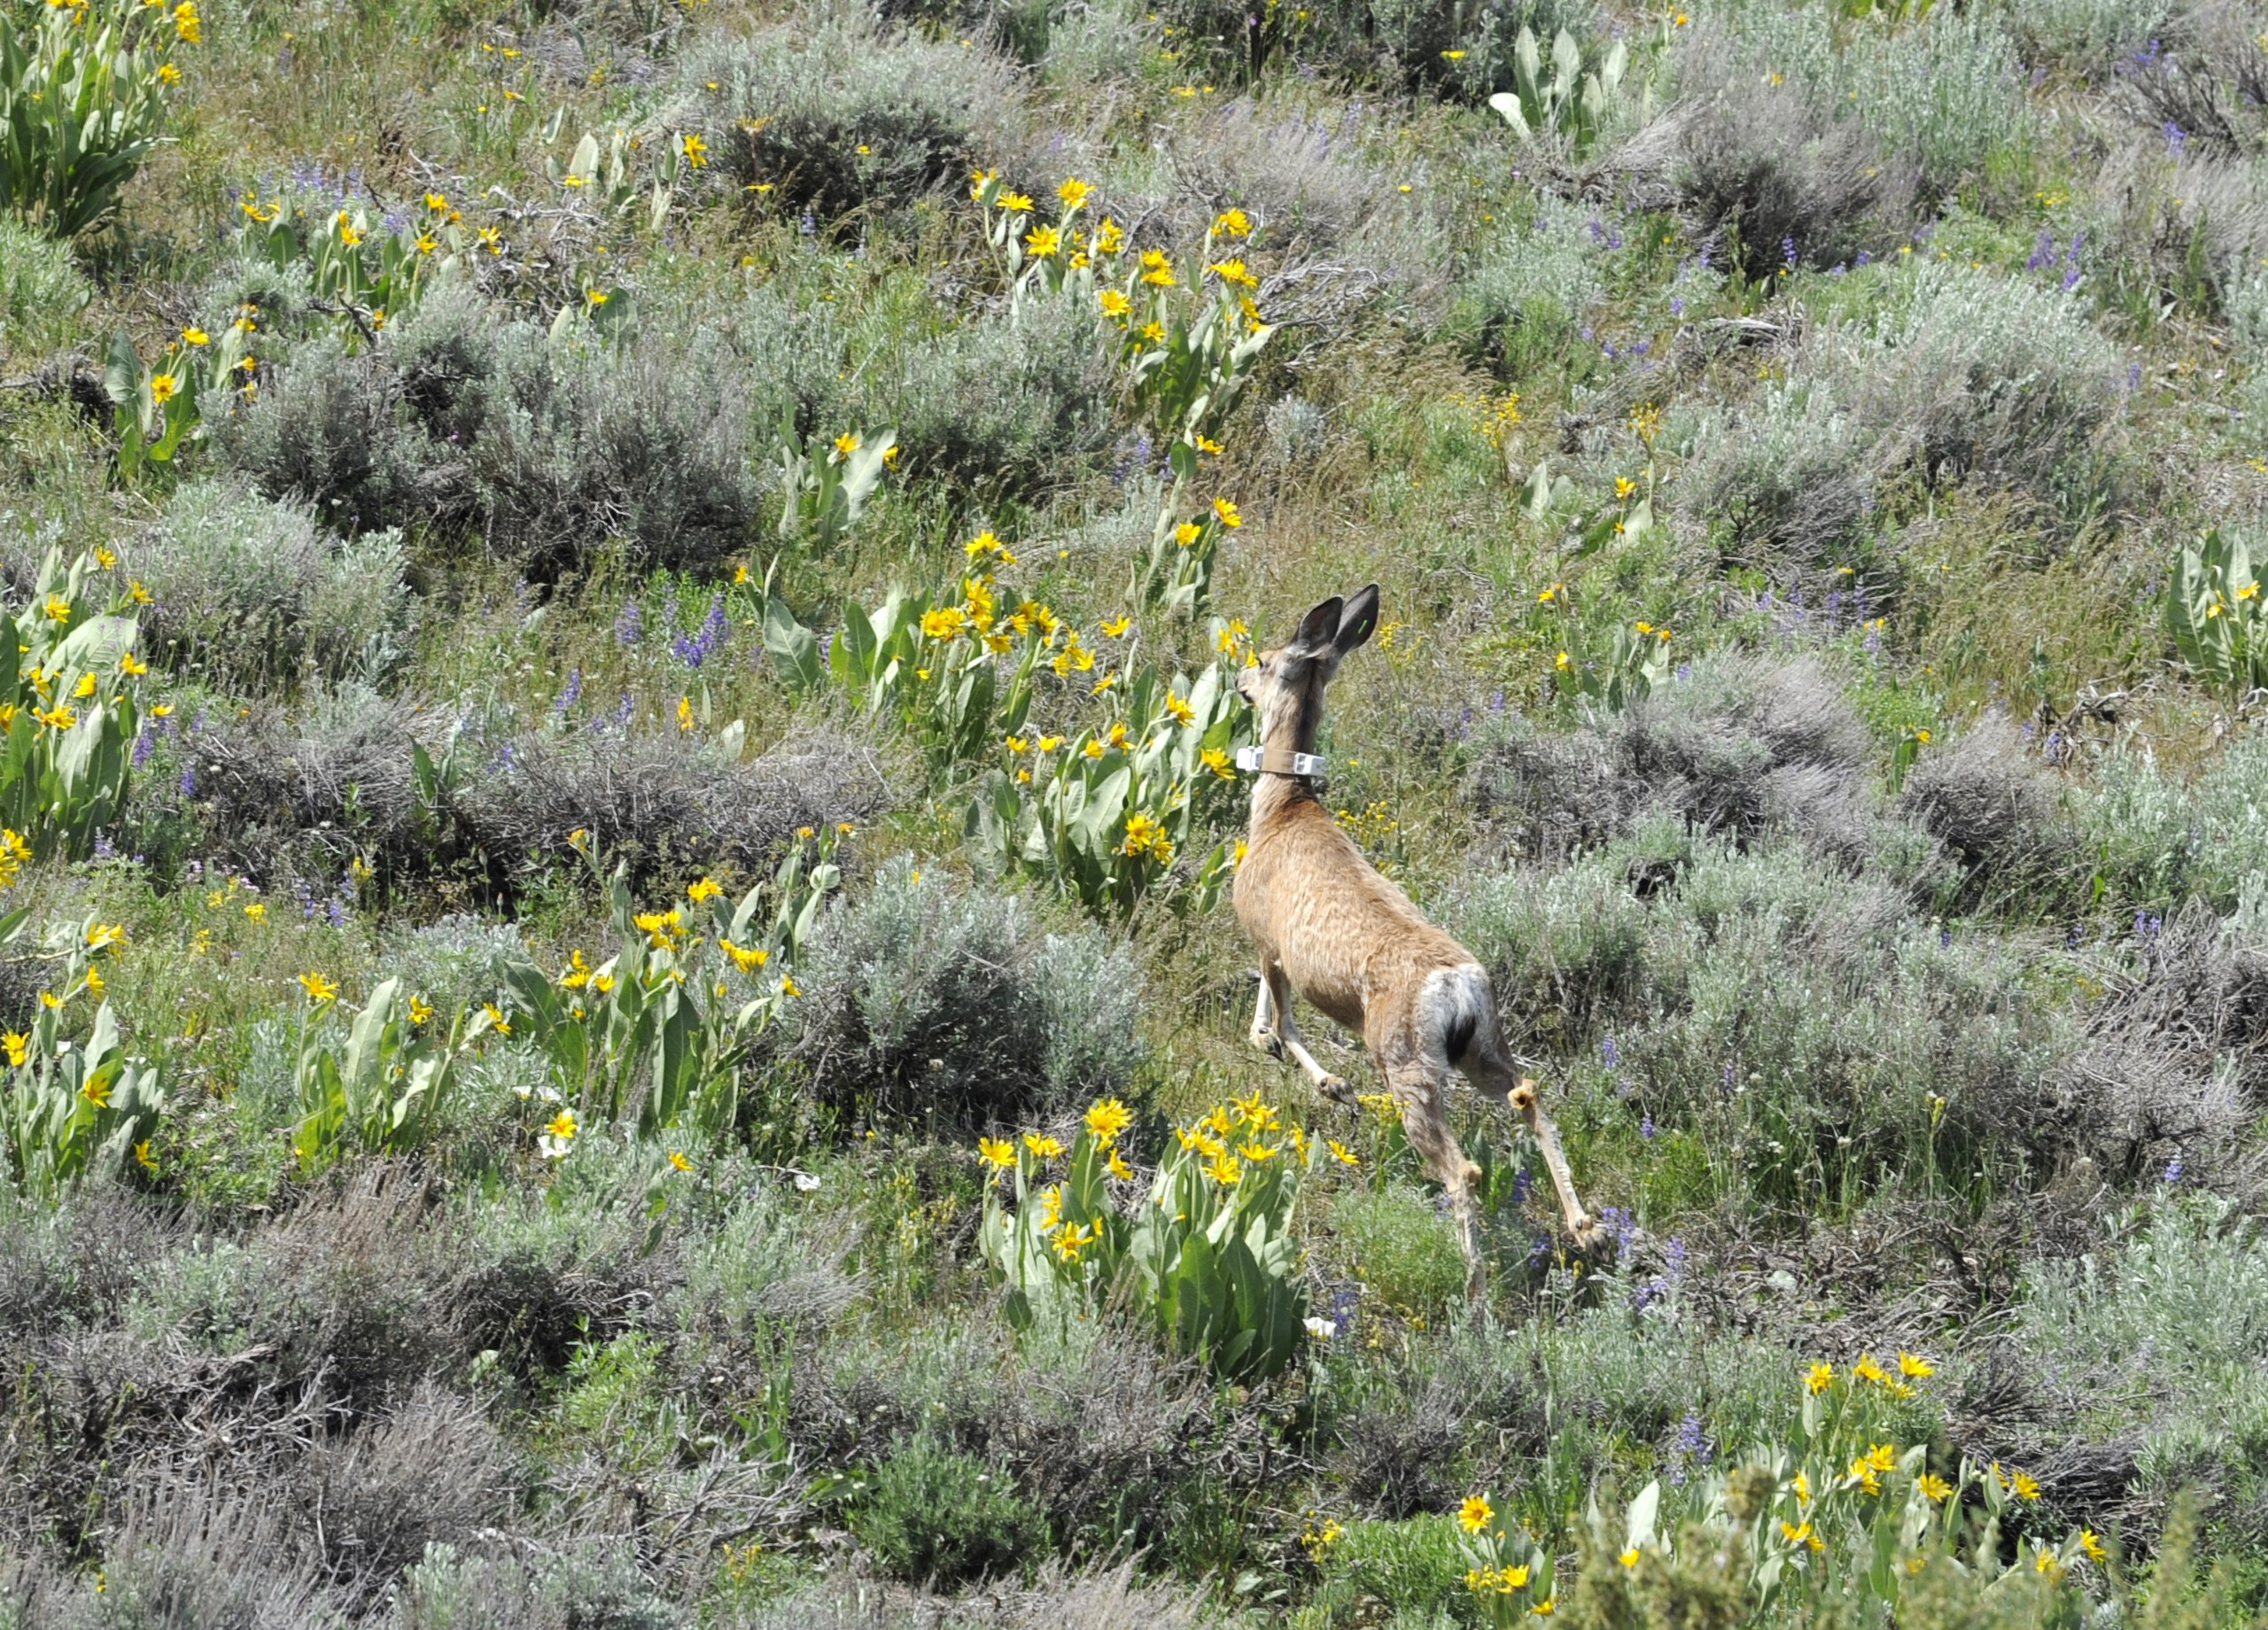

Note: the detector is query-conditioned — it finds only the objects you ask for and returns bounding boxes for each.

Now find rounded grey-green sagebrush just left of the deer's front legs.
[794,861,1141,1127]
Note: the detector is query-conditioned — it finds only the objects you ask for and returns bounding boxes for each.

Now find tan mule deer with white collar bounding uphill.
[1236,583,1599,1288]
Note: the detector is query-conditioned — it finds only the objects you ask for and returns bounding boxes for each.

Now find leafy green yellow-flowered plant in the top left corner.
[0,0,202,238]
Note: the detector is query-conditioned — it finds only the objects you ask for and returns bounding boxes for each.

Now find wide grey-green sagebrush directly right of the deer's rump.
[1458,827,2086,1204]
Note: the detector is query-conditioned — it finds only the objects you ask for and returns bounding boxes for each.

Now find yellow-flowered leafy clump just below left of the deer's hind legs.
[977,1092,1332,1383]
